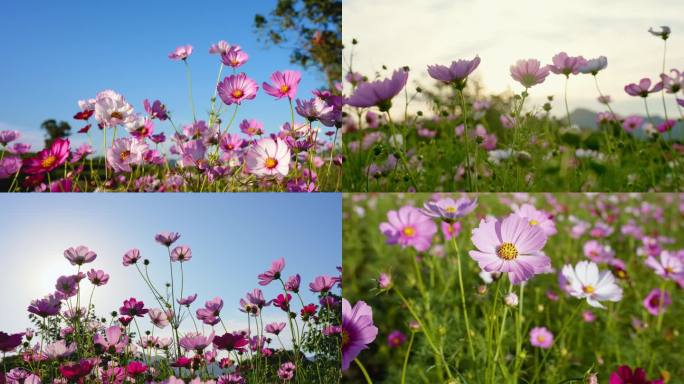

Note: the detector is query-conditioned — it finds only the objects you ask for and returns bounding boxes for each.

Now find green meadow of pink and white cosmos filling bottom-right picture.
[342,193,684,384]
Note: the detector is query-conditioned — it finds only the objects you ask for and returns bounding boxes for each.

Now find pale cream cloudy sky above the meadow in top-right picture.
[343,0,684,118]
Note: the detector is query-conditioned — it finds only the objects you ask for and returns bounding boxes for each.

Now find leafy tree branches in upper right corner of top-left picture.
[254,0,342,89]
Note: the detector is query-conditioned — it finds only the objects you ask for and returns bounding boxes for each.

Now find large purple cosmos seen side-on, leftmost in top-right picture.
[346,69,408,112]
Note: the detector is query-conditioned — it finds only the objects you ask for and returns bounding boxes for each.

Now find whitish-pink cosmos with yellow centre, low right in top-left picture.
[245,137,291,176]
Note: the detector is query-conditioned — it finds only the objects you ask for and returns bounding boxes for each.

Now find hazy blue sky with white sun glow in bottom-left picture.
[0,193,342,340]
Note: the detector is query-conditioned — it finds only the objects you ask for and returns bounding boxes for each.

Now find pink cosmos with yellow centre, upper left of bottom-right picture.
[380,205,437,252]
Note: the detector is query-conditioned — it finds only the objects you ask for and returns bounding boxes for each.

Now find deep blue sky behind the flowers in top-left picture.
[0,0,325,149]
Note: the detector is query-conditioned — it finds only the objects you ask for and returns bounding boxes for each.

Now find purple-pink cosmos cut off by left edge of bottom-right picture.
[342,298,378,371]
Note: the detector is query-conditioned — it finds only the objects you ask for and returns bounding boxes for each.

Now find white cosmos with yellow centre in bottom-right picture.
[562,261,622,308]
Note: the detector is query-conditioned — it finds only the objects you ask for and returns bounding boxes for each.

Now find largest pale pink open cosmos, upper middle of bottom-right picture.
[470,214,551,284]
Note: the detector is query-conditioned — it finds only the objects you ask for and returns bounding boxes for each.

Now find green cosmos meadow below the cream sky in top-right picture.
[343,26,684,192]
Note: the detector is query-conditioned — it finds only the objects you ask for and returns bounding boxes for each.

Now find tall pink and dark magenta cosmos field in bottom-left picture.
[0,232,341,384]
